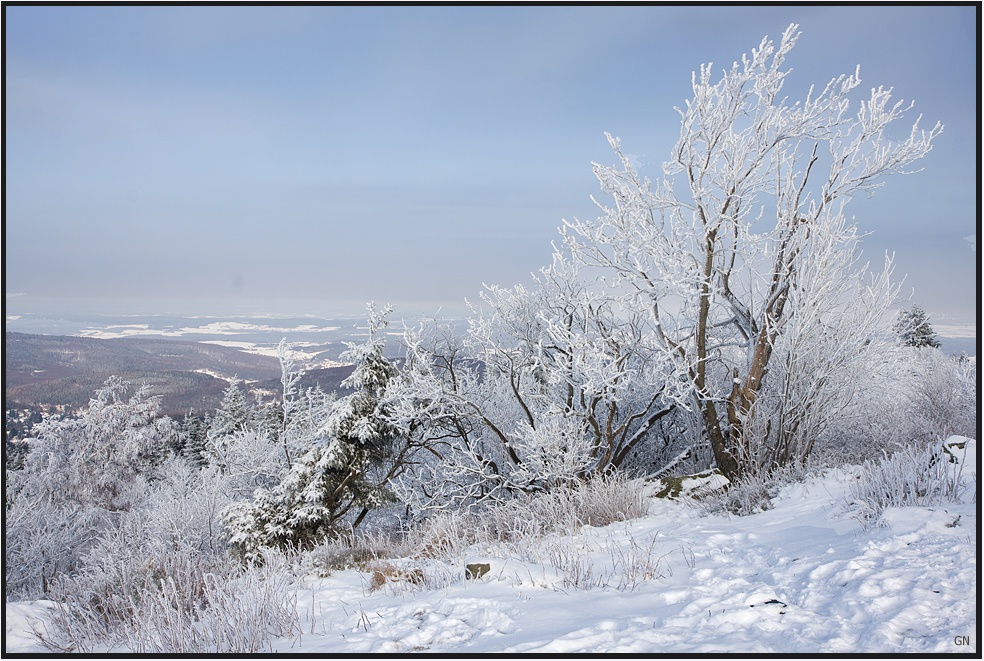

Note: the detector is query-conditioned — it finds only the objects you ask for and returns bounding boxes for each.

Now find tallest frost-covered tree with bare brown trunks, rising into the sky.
[563,25,942,477]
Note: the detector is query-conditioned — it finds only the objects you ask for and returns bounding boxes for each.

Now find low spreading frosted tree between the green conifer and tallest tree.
[393,252,689,507]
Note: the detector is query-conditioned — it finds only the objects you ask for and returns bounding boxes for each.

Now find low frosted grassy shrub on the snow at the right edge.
[845,444,976,528]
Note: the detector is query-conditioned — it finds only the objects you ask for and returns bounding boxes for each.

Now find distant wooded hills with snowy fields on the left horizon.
[4,333,352,417]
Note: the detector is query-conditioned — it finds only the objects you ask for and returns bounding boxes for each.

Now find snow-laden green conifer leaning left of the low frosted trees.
[223,303,399,558]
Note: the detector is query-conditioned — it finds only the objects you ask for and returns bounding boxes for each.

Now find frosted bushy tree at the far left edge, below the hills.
[4,376,177,596]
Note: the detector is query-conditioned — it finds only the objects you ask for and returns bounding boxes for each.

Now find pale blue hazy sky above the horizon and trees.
[4,5,980,322]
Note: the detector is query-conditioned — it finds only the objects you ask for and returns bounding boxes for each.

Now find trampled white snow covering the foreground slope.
[6,444,979,654]
